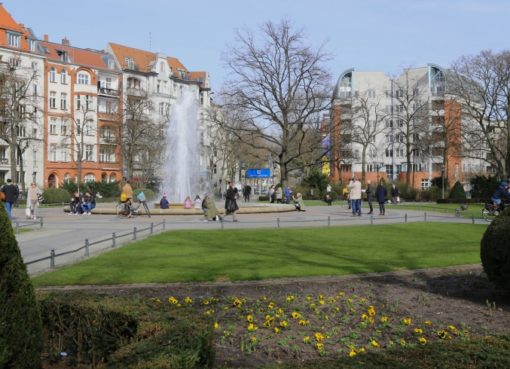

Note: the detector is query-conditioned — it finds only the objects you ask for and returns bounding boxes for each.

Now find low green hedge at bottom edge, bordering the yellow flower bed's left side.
[108,317,214,369]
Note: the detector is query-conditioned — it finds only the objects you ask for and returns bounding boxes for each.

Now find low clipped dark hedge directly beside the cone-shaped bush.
[40,296,138,367]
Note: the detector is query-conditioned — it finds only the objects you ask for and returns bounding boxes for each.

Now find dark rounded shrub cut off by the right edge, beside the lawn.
[480,208,510,290]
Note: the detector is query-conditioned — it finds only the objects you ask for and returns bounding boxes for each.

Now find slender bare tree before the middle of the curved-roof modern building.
[390,69,429,192]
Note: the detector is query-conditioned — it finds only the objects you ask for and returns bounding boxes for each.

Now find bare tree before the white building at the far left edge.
[0,57,41,191]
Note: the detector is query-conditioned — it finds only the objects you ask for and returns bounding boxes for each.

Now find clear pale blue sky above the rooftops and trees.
[3,0,510,90]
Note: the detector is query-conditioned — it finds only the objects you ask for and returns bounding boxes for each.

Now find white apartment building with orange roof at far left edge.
[0,3,44,187]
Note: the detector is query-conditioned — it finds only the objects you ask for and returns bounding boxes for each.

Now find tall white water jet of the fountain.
[160,89,209,204]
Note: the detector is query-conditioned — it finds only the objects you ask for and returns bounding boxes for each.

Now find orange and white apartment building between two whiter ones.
[40,36,122,187]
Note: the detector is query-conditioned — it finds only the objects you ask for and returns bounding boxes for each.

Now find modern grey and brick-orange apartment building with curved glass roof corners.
[330,64,483,189]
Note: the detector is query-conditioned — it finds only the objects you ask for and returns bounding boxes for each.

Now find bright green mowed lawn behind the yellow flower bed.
[34,223,486,286]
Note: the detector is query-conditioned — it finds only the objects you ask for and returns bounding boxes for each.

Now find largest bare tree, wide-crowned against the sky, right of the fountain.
[222,20,331,183]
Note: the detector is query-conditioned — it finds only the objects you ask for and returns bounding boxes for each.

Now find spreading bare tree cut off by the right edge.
[447,50,510,178]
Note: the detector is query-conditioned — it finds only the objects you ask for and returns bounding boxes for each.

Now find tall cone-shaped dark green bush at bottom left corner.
[0,202,42,369]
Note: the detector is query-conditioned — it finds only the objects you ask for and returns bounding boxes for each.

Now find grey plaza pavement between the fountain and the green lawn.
[13,202,471,274]
